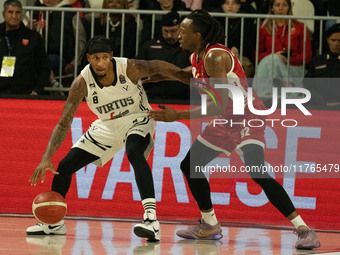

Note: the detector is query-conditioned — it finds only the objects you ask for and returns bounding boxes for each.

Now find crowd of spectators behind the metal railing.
[0,0,340,106]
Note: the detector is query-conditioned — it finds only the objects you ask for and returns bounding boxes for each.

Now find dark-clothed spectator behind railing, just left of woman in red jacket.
[214,0,256,77]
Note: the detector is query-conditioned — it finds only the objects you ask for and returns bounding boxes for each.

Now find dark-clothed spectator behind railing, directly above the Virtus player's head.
[82,0,137,58]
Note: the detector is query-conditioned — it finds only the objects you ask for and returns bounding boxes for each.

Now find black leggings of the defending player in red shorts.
[181,140,295,217]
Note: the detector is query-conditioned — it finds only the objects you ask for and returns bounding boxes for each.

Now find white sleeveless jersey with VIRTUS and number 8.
[81,58,151,121]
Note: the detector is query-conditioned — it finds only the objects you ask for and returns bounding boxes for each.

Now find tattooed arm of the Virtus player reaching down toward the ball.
[29,75,87,186]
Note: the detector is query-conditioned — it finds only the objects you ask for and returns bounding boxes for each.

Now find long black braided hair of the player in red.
[187,10,225,51]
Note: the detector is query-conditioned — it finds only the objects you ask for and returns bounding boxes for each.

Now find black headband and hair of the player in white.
[79,35,112,70]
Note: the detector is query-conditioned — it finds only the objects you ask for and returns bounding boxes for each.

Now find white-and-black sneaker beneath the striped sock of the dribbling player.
[133,212,159,242]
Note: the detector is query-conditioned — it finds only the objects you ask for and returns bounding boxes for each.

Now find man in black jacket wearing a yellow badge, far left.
[0,0,50,95]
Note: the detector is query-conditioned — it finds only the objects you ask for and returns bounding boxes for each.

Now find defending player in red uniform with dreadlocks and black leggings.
[149,11,320,249]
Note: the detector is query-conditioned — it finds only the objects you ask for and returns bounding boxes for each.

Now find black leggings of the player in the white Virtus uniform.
[52,134,155,199]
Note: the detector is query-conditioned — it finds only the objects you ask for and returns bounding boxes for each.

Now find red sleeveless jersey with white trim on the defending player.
[191,44,265,118]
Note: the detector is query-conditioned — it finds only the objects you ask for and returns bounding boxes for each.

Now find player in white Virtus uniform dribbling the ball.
[26,36,187,241]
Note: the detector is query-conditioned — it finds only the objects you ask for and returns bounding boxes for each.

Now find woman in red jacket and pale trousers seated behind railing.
[253,0,312,97]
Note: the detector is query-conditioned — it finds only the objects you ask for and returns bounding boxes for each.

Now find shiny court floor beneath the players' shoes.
[0,216,340,255]
